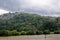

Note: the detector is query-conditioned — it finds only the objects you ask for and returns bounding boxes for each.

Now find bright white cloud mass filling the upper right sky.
[21,0,60,11]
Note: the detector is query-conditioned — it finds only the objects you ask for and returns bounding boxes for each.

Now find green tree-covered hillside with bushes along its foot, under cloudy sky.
[0,12,60,36]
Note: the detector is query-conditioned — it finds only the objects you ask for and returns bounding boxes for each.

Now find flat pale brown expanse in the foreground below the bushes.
[0,34,60,40]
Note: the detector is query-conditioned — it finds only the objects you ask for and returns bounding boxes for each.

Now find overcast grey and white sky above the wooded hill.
[0,0,60,16]
